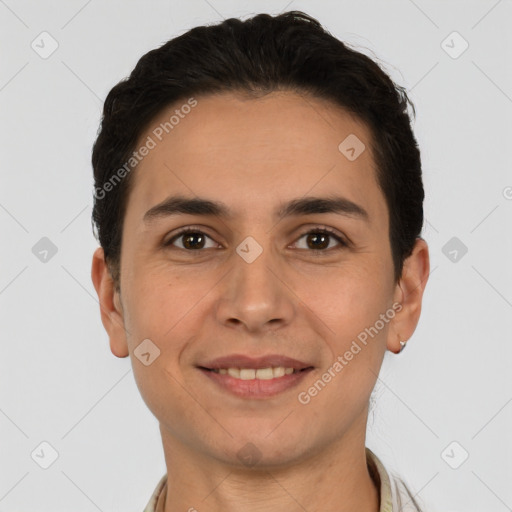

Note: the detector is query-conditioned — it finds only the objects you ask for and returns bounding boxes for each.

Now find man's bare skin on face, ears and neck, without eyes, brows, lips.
[91,92,429,512]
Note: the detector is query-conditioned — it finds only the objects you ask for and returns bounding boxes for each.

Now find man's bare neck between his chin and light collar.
[157,428,380,512]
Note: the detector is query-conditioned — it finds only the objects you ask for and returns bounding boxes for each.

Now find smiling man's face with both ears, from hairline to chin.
[93,92,428,466]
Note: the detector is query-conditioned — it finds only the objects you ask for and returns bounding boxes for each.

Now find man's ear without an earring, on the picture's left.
[91,247,129,357]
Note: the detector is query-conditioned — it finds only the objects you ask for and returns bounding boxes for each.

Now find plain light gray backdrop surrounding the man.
[0,0,512,512]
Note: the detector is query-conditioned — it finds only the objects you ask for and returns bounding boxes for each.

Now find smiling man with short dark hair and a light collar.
[92,11,429,512]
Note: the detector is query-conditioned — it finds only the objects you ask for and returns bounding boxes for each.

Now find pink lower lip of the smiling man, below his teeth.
[199,368,313,399]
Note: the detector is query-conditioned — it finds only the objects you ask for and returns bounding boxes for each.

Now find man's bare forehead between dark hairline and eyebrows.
[128,92,385,226]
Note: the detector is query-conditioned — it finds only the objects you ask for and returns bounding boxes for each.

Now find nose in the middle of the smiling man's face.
[216,239,297,334]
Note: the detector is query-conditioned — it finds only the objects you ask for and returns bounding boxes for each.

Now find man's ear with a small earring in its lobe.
[387,237,430,353]
